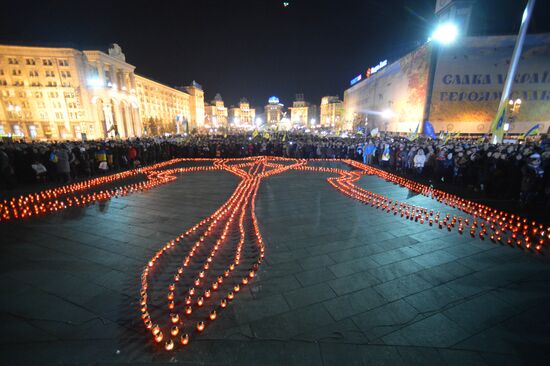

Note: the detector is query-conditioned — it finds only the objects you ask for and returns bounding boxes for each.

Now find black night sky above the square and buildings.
[0,0,550,106]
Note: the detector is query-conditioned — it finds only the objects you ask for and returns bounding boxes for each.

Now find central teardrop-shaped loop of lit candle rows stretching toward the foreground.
[140,157,305,351]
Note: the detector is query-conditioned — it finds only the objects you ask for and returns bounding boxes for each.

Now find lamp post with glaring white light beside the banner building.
[424,22,459,133]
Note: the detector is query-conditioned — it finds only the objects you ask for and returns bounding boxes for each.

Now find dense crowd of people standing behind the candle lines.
[0,132,550,216]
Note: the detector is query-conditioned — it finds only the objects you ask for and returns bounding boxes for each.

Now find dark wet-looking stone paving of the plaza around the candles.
[0,163,550,365]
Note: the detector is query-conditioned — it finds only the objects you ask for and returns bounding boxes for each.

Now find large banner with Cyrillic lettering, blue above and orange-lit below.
[430,34,550,133]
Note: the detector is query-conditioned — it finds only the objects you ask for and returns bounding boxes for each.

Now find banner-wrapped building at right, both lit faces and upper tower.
[344,0,550,135]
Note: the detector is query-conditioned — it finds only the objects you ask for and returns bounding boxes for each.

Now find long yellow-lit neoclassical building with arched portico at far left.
[0,44,204,140]
